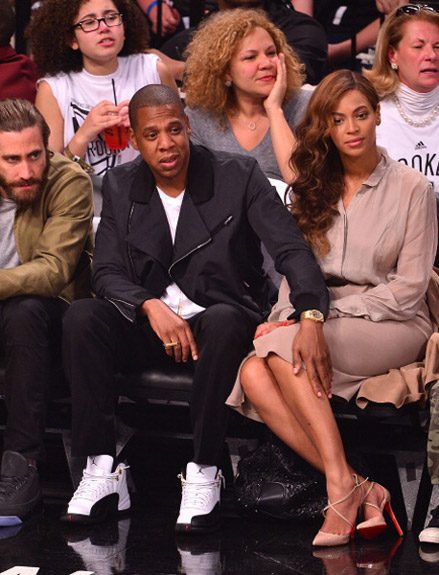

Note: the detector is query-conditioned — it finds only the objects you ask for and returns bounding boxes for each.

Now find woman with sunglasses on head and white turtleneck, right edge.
[365,4,439,195]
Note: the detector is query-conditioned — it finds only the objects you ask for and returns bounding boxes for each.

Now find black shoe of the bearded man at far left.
[0,451,41,527]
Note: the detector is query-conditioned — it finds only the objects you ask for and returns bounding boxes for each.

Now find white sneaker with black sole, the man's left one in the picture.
[62,455,131,523]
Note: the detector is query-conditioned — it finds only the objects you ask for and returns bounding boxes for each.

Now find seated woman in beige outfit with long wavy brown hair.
[228,70,437,546]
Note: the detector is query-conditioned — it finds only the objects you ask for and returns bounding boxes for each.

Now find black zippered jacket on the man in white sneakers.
[93,145,328,321]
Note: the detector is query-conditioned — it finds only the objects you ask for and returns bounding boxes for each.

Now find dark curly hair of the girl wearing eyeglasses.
[27,0,149,76]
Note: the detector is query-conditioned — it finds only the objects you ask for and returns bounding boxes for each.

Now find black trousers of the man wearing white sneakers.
[63,299,258,465]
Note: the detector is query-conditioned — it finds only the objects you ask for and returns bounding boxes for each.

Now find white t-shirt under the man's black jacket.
[157,188,206,319]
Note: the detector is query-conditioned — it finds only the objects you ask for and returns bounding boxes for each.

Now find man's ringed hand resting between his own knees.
[140,299,198,363]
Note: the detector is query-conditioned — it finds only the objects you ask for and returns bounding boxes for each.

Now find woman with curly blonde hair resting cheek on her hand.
[184,8,310,182]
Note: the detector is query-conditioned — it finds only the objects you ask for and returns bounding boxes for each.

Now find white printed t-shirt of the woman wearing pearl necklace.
[377,98,439,195]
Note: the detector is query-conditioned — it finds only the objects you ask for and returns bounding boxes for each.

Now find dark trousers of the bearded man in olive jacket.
[0,296,68,461]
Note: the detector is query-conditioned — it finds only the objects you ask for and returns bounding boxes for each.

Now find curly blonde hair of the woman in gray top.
[184,8,304,121]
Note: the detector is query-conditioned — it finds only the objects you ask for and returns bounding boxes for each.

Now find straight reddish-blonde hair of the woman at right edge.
[364,9,439,98]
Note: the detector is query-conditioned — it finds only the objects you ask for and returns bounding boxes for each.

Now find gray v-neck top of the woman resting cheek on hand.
[186,88,312,180]
